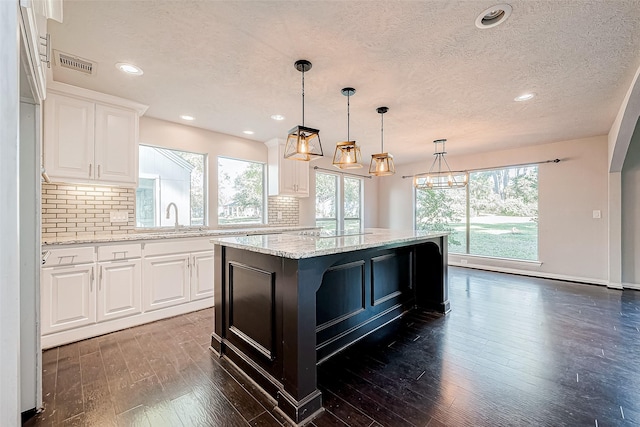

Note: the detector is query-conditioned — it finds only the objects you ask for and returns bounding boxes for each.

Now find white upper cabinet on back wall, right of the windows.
[265,138,309,197]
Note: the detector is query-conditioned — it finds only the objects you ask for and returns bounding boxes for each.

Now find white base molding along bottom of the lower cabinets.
[41,298,213,350]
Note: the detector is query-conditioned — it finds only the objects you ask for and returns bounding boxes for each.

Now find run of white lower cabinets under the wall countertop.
[41,237,218,349]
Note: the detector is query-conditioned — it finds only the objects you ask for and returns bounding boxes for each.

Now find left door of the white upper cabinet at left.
[44,93,95,180]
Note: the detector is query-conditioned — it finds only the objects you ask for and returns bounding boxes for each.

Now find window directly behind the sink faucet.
[136,144,207,227]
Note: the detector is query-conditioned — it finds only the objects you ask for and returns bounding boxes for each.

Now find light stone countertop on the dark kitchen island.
[211,228,449,259]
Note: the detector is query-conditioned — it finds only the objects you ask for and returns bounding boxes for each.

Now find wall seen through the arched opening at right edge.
[622,120,640,289]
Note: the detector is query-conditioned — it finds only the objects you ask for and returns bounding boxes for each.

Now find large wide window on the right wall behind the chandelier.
[415,166,538,261]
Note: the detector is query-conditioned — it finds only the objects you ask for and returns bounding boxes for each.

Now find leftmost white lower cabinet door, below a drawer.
[40,264,96,334]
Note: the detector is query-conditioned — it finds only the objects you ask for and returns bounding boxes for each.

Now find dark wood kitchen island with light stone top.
[211,229,449,423]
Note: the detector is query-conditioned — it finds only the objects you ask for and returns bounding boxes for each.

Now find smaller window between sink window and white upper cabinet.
[218,157,266,225]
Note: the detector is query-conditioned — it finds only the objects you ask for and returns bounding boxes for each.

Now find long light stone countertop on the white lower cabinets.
[42,226,315,246]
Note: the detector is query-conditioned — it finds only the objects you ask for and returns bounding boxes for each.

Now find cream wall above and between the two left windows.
[139,117,267,228]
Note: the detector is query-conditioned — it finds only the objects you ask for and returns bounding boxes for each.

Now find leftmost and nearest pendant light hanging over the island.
[284,59,323,162]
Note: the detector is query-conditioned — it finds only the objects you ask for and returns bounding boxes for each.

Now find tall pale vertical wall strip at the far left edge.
[0,5,22,427]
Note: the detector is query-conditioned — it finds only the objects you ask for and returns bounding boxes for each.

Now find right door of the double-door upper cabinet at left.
[95,104,138,184]
